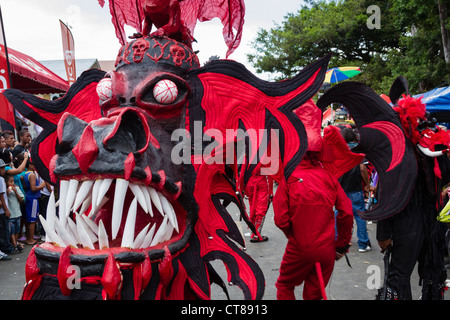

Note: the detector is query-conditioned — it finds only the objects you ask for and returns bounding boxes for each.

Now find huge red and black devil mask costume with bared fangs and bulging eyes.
[0,0,342,300]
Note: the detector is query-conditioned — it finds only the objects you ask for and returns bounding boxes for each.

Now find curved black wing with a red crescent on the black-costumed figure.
[317,82,417,220]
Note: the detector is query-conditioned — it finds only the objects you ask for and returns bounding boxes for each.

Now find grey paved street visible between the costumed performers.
[0,198,450,300]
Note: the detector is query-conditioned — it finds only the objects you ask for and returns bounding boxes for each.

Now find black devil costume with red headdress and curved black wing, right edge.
[318,77,450,300]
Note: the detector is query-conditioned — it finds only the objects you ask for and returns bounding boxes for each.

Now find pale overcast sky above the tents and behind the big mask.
[0,0,304,78]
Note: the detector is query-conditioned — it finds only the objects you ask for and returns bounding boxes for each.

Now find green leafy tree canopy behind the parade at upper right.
[248,0,450,93]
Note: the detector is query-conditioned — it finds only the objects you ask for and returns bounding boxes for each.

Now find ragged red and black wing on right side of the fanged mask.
[187,56,329,299]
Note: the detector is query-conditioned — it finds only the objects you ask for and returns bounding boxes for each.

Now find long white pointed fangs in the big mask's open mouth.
[39,179,179,249]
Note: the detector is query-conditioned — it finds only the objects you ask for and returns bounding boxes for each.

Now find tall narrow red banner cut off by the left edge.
[0,8,16,129]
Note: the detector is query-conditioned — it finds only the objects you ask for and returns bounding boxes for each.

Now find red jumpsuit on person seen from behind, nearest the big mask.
[273,159,353,300]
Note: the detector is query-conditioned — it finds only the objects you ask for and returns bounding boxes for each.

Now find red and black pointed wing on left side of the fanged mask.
[3,69,105,183]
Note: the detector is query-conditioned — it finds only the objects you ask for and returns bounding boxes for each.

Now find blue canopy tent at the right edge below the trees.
[414,86,450,123]
